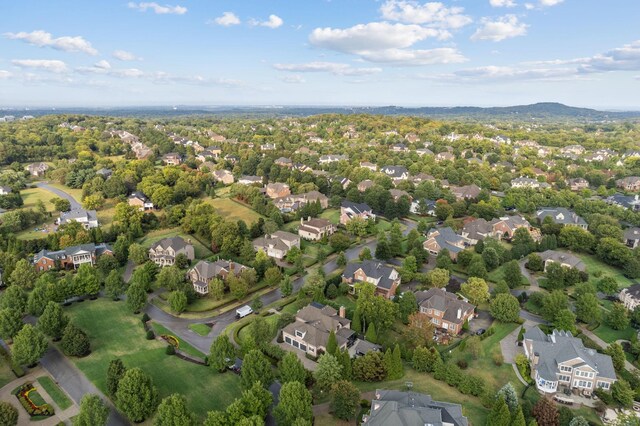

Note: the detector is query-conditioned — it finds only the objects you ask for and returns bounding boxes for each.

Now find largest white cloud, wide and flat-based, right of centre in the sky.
[309,22,466,65]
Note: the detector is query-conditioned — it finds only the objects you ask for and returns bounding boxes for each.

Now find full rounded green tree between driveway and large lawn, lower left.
[116,368,158,423]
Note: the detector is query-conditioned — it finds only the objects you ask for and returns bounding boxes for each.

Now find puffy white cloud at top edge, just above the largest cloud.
[380,0,476,29]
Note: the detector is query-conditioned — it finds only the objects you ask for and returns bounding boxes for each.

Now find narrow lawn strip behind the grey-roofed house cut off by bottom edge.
[355,366,484,425]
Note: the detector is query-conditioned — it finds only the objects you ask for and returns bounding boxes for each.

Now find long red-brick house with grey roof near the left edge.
[33,243,113,271]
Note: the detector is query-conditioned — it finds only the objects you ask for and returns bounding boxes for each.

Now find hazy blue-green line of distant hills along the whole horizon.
[5,102,640,121]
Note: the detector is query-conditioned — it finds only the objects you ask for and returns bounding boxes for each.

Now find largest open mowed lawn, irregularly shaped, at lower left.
[65,299,242,421]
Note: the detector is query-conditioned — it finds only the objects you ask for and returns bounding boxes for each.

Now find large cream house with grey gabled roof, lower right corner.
[524,327,617,394]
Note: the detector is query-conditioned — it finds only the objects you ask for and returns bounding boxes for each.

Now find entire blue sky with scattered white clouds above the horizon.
[0,0,640,109]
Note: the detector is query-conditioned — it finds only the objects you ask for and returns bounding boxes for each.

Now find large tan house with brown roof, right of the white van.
[282,302,356,357]
